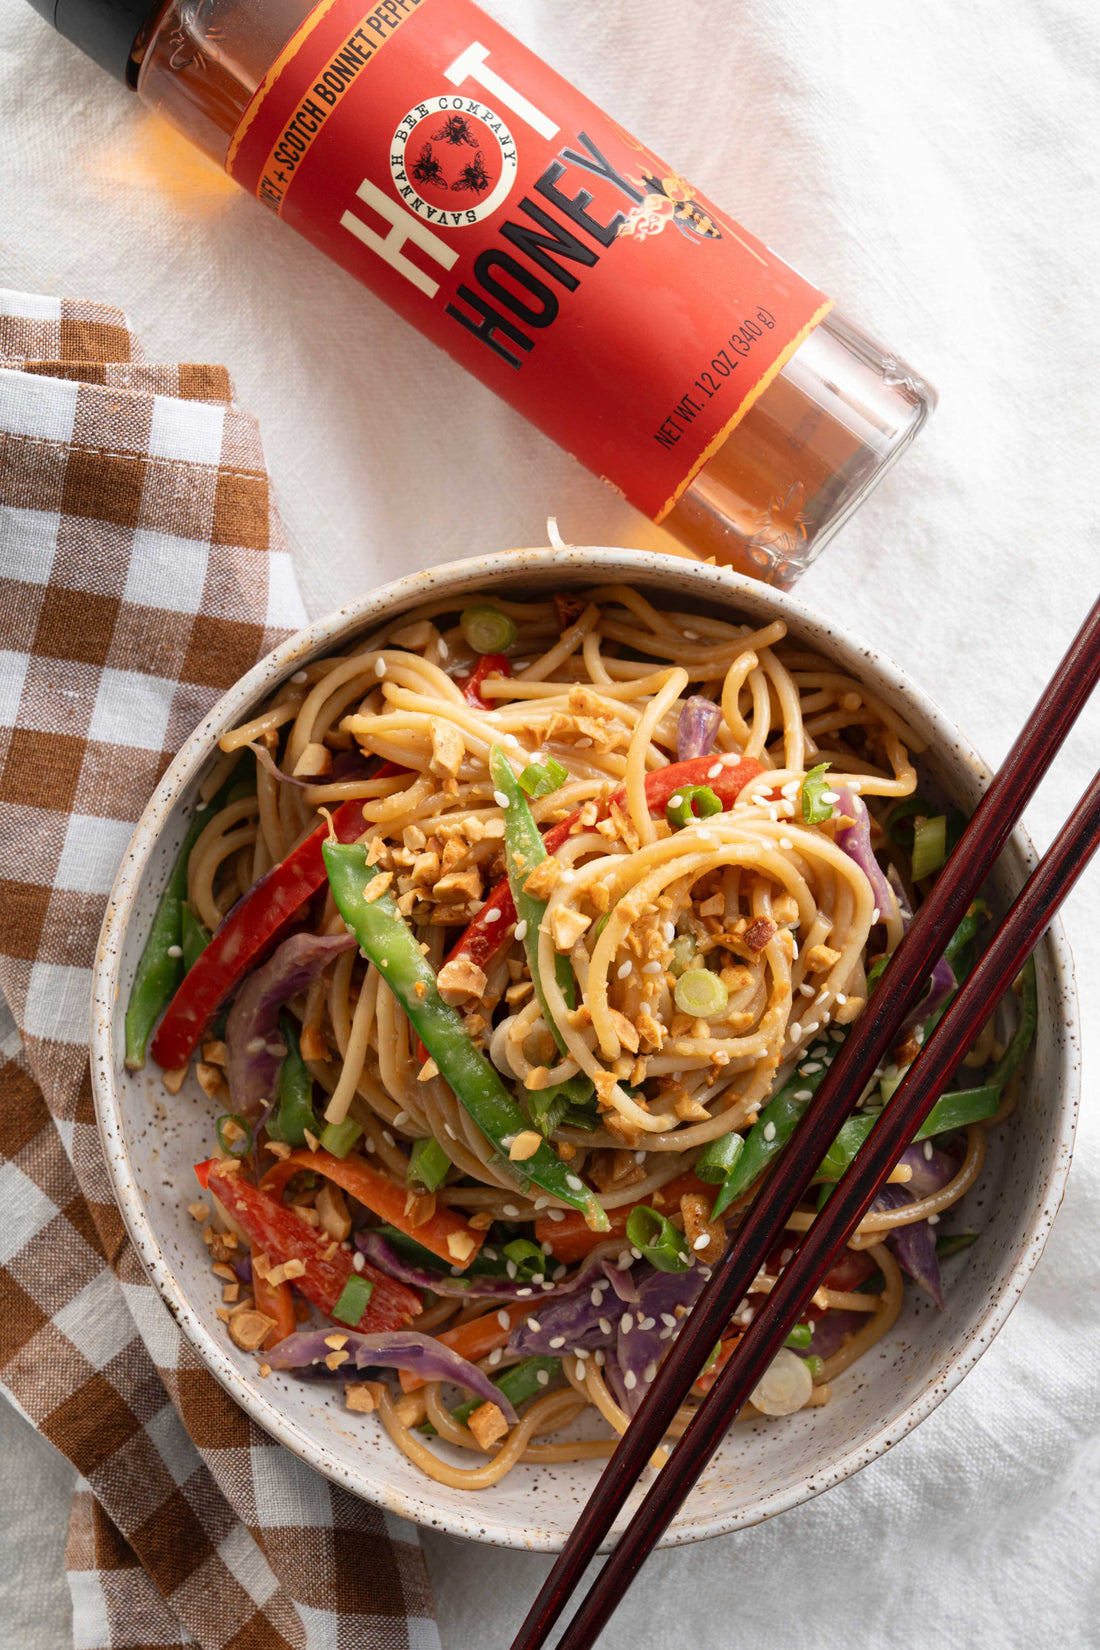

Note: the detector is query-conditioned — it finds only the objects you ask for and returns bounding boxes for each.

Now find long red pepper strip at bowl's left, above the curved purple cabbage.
[152,800,366,1071]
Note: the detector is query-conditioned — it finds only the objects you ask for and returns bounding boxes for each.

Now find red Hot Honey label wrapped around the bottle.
[226,0,831,521]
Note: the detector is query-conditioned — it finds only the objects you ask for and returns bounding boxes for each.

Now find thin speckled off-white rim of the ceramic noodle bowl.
[91,546,1080,1551]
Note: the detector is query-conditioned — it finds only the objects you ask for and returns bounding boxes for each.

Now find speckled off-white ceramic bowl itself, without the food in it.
[92,548,1079,1551]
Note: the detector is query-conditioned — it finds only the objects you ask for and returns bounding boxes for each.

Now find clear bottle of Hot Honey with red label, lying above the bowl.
[33,0,935,586]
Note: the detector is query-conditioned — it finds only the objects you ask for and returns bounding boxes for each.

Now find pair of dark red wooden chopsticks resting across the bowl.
[511,601,1100,1650]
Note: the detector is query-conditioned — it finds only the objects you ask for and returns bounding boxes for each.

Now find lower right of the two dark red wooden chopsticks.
[557,772,1100,1650]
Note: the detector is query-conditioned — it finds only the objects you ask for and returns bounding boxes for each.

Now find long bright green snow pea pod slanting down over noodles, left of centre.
[322,842,609,1231]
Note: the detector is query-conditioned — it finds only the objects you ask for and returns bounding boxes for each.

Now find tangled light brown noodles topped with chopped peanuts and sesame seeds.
[159,584,1019,1490]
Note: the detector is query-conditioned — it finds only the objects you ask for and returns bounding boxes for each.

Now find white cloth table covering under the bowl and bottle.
[0,0,1100,1650]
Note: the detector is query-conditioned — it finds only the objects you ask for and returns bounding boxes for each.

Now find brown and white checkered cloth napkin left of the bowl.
[0,292,439,1650]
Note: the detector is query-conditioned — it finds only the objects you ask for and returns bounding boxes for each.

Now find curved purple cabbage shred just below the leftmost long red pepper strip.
[226,934,355,1117]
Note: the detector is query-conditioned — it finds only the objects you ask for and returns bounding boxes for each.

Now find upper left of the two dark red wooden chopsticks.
[511,601,1100,1650]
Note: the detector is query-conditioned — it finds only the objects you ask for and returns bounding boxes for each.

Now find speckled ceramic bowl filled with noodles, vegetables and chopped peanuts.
[92,548,1079,1551]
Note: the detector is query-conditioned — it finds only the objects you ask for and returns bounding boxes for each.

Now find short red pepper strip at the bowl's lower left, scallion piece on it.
[208,1163,422,1335]
